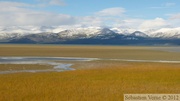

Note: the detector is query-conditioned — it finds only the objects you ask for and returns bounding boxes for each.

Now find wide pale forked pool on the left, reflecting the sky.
[0,57,94,74]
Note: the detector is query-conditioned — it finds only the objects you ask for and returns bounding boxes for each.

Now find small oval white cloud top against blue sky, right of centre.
[95,7,126,16]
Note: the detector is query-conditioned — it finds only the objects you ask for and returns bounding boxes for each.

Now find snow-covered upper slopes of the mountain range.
[0,26,180,40]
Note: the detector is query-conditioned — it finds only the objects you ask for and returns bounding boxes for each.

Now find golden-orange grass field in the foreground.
[0,61,180,101]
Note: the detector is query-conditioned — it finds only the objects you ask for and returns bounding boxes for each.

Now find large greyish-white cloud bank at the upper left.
[0,2,76,26]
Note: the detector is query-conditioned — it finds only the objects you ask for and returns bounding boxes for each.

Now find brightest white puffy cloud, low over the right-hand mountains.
[139,18,168,30]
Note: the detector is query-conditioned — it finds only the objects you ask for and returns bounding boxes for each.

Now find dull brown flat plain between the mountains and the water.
[0,45,180,60]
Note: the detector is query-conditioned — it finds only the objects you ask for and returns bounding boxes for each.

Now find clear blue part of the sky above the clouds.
[29,0,180,19]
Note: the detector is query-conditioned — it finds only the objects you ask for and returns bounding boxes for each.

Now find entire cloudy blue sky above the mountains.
[0,0,180,30]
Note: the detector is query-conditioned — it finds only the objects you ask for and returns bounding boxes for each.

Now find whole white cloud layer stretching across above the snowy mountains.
[0,0,177,31]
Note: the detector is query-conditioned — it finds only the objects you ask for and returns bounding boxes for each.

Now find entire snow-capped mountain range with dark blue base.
[0,26,180,45]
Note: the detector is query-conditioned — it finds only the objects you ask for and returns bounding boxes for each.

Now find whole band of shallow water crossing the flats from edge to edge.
[0,56,180,74]
